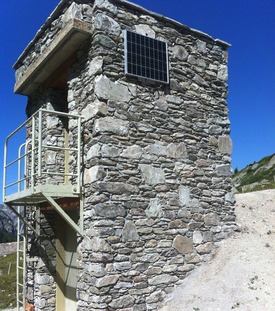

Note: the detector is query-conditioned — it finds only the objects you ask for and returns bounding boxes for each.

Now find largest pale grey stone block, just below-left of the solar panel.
[95,75,131,102]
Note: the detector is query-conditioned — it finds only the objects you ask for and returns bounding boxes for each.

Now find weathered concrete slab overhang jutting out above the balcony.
[14,19,92,95]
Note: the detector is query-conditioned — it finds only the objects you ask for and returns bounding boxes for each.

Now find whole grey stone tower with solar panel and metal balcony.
[5,0,235,311]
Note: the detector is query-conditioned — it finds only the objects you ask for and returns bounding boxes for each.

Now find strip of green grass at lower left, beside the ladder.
[0,253,16,310]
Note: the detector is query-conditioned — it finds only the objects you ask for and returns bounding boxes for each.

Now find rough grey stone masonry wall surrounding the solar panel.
[14,0,235,311]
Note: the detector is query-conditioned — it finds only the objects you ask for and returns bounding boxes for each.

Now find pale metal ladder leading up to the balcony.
[16,206,27,310]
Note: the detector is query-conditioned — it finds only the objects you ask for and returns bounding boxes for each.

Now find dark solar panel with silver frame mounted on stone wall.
[124,31,169,83]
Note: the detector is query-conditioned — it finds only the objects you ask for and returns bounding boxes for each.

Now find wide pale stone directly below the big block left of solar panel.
[94,117,129,136]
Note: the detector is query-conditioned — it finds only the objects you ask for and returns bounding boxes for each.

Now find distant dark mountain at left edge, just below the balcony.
[0,204,17,243]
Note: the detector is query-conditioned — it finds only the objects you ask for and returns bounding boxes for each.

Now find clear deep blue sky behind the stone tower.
[0,0,275,200]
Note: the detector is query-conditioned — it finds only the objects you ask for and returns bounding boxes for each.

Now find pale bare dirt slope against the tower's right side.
[160,190,275,311]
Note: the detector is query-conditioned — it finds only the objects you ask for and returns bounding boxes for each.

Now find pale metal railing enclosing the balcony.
[3,109,81,202]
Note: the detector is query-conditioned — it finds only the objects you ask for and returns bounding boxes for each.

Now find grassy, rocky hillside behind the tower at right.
[233,153,275,193]
